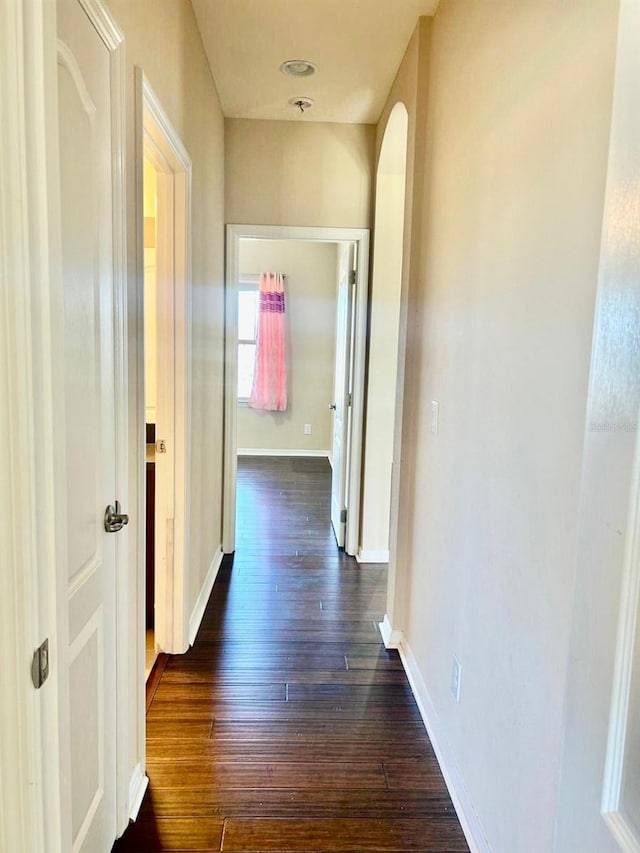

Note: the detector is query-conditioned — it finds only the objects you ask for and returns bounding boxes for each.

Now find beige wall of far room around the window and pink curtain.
[237,240,337,451]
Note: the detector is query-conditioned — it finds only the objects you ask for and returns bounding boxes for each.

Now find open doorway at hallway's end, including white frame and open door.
[224,226,368,554]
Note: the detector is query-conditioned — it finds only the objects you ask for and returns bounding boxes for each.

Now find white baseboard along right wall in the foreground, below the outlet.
[398,628,491,853]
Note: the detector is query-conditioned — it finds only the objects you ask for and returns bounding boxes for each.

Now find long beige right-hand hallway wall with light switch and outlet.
[379,0,618,853]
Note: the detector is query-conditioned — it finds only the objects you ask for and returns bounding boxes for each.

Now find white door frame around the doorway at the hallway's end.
[223,225,369,554]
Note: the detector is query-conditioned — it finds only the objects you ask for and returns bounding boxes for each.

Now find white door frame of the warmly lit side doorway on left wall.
[135,67,192,656]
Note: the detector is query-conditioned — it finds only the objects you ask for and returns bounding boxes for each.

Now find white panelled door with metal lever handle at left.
[57,0,124,851]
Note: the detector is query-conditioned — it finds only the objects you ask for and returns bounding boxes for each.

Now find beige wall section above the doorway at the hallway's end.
[225,119,375,228]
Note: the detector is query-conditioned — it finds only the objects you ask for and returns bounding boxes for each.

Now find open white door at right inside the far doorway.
[331,244,355,548]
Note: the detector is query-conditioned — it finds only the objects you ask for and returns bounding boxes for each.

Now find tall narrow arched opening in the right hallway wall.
[357,103,408,563]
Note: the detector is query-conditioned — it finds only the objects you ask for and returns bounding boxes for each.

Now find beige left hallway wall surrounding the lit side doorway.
[109,0,224,784]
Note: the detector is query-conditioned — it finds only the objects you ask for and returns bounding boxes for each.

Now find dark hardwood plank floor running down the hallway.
[114,458,468,853]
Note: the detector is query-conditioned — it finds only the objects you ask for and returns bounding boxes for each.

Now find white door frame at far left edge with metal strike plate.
[0,0,61,851]
